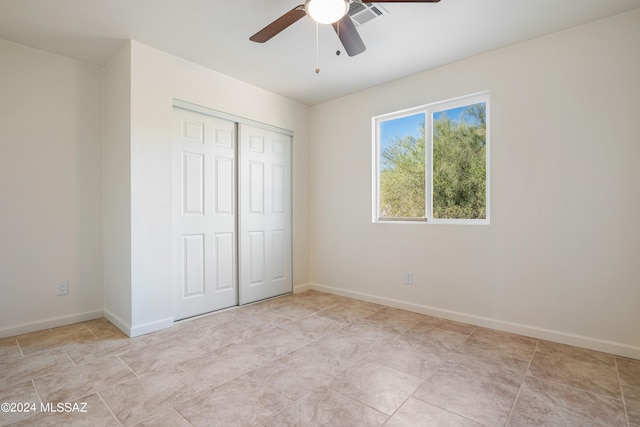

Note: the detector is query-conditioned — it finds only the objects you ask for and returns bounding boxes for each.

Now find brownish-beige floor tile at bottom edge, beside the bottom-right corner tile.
[509,377,627,427]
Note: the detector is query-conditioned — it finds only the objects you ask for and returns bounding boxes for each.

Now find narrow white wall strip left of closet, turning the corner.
[102,43,131,331]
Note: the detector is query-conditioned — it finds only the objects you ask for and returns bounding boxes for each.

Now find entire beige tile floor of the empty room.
[0,291,640,427]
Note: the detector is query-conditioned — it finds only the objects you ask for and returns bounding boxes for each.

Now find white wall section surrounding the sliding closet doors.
[125,41,309,335]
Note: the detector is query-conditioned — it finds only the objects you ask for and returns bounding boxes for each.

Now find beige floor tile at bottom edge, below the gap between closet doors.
[175,377,291,427]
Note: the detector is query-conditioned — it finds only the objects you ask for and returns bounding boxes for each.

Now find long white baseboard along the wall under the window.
[305,283,640,359]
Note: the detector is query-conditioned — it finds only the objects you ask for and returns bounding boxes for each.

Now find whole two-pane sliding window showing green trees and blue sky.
[373,93,489,224]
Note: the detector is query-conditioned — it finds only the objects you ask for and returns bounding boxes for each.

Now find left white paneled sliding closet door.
[173,108,238,320]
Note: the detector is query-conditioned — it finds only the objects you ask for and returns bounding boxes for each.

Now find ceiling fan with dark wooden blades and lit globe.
[249,0,440,56]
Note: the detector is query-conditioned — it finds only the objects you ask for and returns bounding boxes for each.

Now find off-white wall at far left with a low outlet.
[0,41,103,337]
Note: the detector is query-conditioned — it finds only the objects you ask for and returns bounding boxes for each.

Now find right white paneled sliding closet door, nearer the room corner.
[239,124,293,304]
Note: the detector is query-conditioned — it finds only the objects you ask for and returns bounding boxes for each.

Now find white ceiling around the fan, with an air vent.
[0,0,640,105]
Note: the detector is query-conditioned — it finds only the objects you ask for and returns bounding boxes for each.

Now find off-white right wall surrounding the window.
[310,10,640,358]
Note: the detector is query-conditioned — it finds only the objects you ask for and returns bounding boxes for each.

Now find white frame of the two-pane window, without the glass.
[371,91,491,225]
